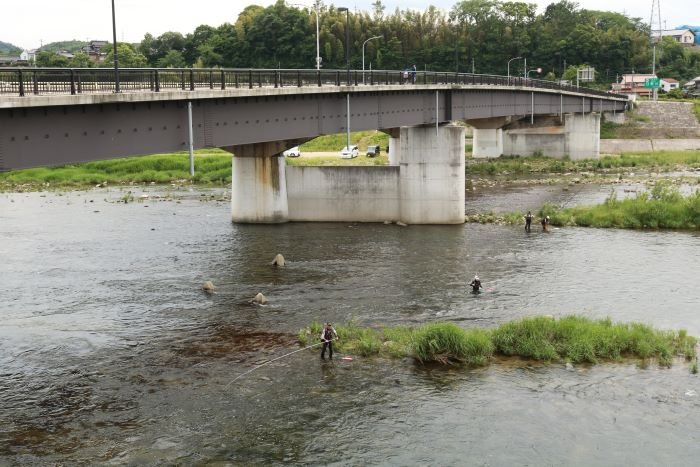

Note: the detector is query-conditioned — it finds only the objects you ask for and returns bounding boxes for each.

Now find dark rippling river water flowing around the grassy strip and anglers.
[0,186,700,466]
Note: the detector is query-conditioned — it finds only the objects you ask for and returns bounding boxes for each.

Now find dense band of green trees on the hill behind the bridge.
[30,0,700,83]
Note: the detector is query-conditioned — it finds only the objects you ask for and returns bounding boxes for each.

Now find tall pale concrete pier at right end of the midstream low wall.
[399,125,465,224]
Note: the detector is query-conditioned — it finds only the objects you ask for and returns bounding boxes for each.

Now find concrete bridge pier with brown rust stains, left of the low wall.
[225,141,289,224]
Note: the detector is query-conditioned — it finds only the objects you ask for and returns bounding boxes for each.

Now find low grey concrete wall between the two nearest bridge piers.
[287,166,400,222]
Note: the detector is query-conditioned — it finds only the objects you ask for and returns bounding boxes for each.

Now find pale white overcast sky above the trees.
[0,0,700,49]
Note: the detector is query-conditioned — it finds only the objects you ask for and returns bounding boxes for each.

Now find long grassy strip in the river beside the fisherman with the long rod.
[299,316,697,372]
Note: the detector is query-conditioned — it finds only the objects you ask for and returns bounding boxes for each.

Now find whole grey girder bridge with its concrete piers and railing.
[0,68,627,223]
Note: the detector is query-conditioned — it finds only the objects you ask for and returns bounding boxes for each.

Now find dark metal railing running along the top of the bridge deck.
[0,68,624,98]
